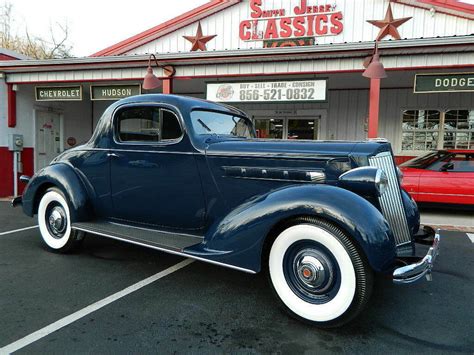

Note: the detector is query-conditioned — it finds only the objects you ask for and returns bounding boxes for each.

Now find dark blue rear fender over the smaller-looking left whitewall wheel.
[22,163,92,222]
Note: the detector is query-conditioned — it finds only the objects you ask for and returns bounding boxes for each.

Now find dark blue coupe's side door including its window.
[109,105,205,229]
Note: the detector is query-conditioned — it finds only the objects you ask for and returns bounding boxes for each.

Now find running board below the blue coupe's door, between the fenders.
[72,221,203,252]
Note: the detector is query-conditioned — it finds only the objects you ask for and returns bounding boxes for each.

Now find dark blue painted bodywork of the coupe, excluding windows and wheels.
[23,95,419,271]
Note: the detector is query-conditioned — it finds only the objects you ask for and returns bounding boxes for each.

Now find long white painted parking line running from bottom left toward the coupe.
[0,259,194,355]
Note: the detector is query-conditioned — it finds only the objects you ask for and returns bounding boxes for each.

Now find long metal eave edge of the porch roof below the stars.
[0,34,474,72]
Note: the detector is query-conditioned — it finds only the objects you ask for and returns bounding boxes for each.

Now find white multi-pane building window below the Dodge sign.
[402,110,474,151]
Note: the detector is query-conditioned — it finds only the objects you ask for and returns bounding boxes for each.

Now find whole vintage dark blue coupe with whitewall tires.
[13,95,439,327]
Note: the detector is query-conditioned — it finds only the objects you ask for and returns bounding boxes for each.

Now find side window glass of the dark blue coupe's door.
[115,106,182,143]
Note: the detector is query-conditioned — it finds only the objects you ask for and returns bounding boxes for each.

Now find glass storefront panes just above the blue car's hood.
[254,116,321,140]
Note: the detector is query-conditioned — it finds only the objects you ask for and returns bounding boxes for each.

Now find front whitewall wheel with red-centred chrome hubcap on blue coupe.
[268,218,373,328]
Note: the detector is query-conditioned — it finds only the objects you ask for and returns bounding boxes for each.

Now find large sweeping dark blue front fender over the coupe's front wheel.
[185,185,396,272]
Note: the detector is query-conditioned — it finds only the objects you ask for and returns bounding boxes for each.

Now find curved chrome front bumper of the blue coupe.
[393,229,440,285]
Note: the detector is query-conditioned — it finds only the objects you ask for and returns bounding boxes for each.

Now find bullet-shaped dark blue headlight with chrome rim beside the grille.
[339,166,388,196]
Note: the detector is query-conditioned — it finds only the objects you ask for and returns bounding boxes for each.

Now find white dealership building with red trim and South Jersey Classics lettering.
[0,0,474,197]
